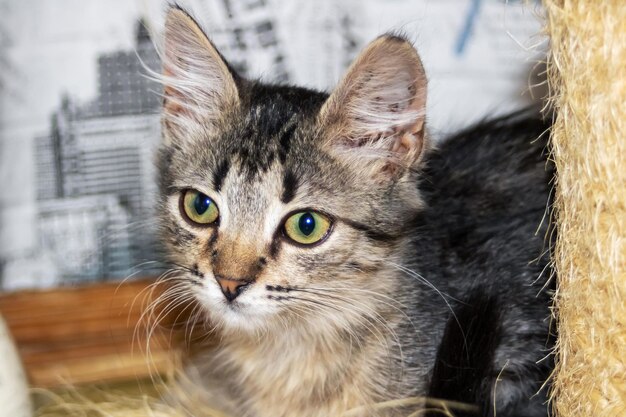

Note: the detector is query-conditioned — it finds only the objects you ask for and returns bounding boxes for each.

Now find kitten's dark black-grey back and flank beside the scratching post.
[416,110,554,416]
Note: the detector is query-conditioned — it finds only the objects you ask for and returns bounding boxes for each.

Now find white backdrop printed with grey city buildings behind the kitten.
[0,0,545,290]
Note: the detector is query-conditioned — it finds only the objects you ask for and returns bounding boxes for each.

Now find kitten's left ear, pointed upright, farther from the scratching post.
[162,7,239,140]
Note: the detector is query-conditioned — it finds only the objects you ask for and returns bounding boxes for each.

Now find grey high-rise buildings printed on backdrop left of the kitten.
[35,24,160,281]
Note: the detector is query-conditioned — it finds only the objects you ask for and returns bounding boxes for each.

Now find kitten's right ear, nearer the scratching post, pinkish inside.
[318,35,426,173]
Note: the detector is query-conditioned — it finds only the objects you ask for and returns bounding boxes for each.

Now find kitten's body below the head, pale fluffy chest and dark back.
[171,112,552,417]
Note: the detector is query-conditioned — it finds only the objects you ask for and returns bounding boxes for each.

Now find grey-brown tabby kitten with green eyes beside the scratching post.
[158,8,552,417]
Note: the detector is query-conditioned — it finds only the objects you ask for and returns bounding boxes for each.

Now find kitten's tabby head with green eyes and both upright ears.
[159,9,426,330]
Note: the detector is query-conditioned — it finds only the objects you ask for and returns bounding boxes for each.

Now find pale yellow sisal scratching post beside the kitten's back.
[544,0,626,417]
